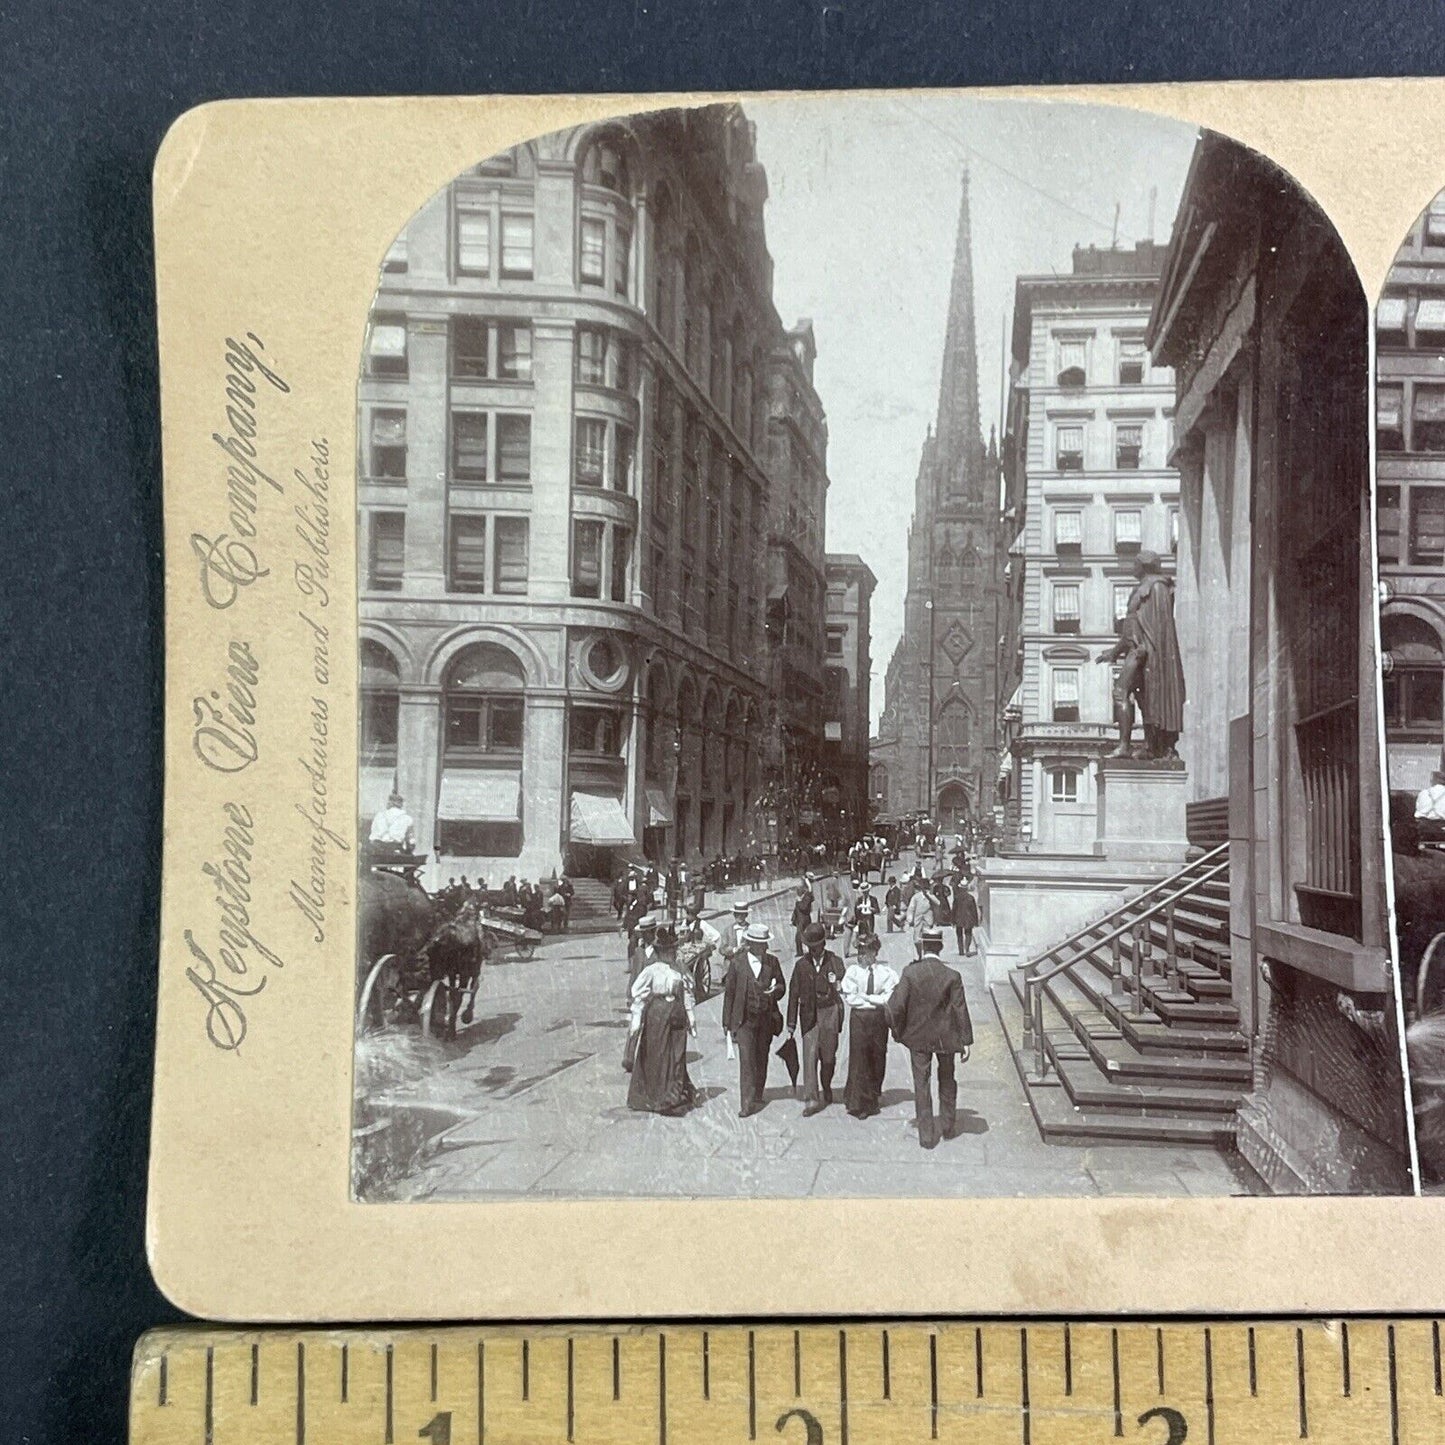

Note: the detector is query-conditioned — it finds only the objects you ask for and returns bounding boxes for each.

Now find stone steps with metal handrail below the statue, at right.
[993,847,1251,1146]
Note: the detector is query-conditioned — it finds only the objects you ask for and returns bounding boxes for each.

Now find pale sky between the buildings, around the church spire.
[744,95,1195,734]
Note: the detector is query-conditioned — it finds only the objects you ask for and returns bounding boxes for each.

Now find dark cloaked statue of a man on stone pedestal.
[1095,551,1185,760]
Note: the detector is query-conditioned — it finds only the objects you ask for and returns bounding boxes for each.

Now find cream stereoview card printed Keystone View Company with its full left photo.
[149,81,1445,1321]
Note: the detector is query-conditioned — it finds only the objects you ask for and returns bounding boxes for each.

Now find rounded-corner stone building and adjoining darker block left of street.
[357,105,827,881]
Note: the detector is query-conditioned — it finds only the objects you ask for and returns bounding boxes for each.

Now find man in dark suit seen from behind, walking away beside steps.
[887,925,974,1149]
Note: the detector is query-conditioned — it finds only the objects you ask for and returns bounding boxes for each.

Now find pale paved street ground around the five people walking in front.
[355,894,1244,1199]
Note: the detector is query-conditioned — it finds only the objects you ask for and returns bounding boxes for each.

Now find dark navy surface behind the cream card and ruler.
[0,0,1445,1445]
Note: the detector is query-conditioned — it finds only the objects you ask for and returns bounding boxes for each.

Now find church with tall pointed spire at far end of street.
[871,171,998,831]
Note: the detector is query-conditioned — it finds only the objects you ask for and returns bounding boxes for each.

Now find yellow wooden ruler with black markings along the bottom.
[130,1319,1445,1445]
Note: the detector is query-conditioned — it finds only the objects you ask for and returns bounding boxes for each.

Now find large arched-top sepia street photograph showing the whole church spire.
[351,95,1410,1202]
